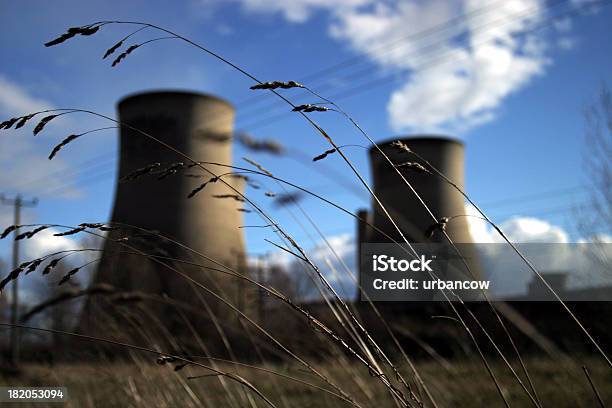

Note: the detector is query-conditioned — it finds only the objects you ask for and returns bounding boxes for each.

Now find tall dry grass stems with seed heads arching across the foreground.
[0,21,612,407]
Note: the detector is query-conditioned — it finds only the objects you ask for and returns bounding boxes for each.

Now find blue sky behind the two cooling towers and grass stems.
[0,0,612,270]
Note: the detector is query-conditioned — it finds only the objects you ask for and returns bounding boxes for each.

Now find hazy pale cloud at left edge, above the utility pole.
[0,74,78,198]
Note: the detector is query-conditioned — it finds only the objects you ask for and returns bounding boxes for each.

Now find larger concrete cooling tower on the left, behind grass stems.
[80,92,247,342]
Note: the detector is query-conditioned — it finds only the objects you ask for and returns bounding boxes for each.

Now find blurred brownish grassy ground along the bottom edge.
[1,357,612,407]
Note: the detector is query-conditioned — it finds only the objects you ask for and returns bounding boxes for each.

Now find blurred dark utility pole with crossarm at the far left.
[0,194,38,368]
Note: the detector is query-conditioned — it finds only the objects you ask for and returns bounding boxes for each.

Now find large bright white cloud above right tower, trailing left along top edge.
[227,0,597,134]
